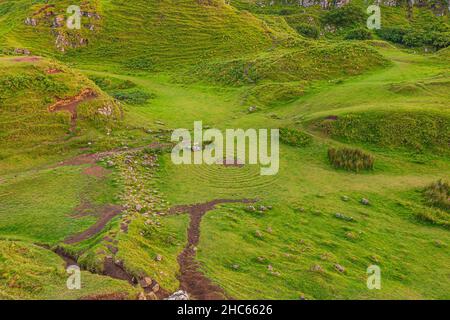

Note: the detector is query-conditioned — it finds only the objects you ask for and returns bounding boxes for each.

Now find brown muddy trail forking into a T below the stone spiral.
[170,199,256,300]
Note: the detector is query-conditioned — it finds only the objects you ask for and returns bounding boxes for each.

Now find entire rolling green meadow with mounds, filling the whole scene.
[0,0,450,300]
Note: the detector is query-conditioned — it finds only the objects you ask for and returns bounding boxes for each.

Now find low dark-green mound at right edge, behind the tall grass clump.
[320,111,450,153]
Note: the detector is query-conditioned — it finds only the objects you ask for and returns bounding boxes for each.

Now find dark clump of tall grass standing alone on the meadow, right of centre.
[328,148,375,172]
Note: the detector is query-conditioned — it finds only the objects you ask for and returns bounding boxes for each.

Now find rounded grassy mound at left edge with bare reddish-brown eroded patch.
[0,57,121,174]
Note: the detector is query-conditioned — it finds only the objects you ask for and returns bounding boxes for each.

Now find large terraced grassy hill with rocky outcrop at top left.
[0,0,285,71]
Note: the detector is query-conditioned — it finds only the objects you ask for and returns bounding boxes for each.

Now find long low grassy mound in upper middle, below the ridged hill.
[190,42,387,85]
